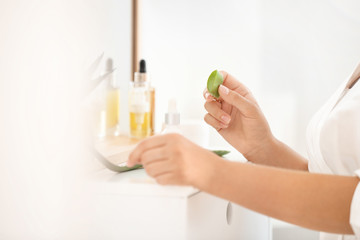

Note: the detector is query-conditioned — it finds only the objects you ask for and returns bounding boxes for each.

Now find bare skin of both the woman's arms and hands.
[128,72,359,234]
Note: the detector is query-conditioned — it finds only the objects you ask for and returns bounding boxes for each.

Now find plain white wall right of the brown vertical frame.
[142,0,360,155]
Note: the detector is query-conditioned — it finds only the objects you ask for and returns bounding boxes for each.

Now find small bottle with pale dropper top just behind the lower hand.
[161,99,181,134]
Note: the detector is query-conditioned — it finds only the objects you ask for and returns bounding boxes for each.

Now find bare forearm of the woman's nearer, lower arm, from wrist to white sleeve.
[195,161,359,234]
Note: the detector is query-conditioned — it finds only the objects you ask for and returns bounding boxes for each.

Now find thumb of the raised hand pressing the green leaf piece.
[219,85,256,117]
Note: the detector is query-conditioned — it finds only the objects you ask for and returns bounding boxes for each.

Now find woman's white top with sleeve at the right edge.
[307,65,360,240]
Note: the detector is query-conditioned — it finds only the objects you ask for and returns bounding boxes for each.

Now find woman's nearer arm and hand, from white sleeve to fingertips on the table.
[128,134,359,234]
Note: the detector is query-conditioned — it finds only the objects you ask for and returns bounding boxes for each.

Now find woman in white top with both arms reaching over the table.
[128,62,360,239]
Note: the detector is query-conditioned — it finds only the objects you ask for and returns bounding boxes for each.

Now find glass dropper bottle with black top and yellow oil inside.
[129,60,151,139]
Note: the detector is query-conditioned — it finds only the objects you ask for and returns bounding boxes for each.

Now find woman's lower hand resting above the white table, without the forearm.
[127,134,224,188]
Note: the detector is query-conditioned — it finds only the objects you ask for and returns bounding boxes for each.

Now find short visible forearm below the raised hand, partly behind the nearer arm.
[245,138,308,171]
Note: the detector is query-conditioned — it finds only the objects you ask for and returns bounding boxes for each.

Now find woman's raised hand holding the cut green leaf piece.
[204,71,275,162]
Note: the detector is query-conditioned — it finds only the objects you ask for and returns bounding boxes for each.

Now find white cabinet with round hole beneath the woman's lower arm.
[80,170,271,240]
